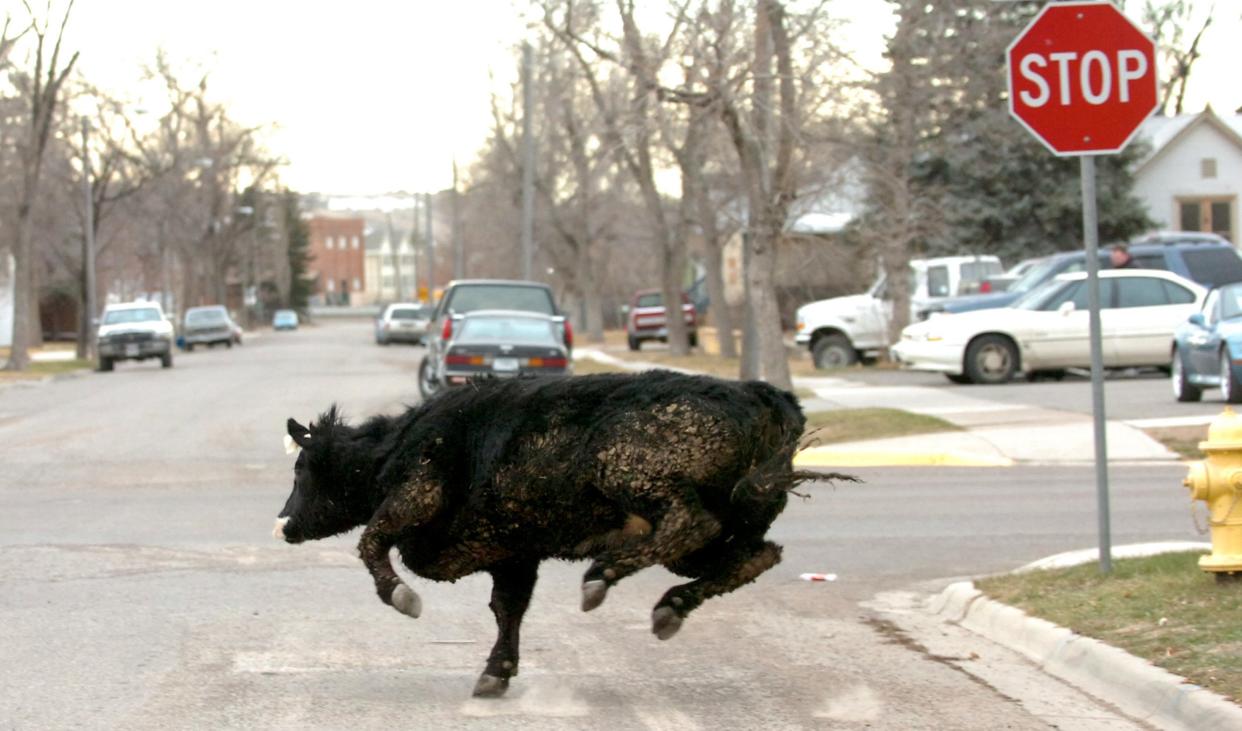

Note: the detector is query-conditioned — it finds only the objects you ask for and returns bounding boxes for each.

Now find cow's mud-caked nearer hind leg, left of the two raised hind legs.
[582,486,720,612]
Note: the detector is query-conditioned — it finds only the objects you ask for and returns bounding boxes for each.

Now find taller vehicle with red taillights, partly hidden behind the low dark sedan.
[419,279,574,398]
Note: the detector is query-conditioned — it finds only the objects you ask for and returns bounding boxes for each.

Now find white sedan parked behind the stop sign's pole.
[893,269,1207,383]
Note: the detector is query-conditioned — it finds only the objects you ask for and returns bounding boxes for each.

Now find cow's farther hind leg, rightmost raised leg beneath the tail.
[651,537,781,639]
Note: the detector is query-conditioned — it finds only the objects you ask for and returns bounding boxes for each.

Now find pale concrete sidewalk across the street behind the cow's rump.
[574,348,1177,467]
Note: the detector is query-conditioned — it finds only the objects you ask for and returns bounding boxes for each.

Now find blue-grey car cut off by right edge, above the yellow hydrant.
[1170,283,1242,403]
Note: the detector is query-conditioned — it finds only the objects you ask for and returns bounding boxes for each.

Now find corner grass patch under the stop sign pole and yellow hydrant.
[976,552,1242,702]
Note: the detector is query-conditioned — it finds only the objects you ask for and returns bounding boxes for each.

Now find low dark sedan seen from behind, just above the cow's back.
[438,310,573,386]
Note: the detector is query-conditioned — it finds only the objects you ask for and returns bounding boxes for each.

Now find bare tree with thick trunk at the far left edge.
[6,0,78,371]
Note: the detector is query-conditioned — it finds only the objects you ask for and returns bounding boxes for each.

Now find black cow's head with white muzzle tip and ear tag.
[272,407,370,544]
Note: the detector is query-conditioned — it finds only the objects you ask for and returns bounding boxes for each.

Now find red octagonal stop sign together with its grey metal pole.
[1006,0,1156,573]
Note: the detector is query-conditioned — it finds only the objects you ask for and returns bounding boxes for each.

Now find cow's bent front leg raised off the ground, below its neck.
[358,483,441,617]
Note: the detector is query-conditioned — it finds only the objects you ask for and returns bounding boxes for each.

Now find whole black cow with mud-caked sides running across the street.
[276,371,843,696]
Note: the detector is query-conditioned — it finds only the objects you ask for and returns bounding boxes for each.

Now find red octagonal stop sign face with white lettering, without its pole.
[1006,2,1156,155]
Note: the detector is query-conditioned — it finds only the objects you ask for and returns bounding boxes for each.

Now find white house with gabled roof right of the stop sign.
[1134,107,1242,243]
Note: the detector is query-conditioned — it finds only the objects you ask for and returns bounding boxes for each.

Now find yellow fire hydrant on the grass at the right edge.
[1182,406,1242,581]
